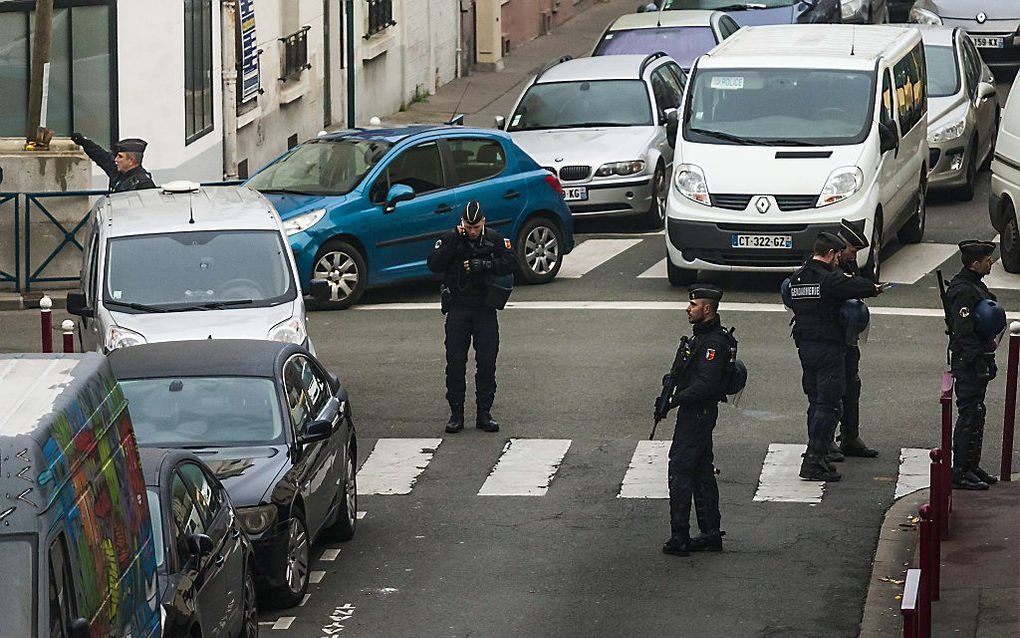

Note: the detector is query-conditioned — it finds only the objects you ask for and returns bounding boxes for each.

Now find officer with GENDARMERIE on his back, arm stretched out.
[789,233,881,481]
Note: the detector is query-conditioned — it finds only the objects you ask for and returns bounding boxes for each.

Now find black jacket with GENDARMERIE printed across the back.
[789,258,878,343]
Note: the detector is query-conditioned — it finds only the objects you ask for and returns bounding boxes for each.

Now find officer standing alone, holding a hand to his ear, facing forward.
[428,201,517,434]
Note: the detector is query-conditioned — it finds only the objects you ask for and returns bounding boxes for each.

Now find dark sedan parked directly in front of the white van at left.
[110,340,357,606]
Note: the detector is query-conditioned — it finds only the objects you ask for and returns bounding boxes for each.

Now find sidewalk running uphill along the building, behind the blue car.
[383,0,639,128]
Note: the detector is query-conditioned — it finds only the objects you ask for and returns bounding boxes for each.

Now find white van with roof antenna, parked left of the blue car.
[67,182,320,353]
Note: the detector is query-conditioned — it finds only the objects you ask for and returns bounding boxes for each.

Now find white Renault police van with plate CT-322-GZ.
[666,24,928,285]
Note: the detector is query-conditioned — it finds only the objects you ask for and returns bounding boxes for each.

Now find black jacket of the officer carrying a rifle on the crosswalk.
[673,316,729,407]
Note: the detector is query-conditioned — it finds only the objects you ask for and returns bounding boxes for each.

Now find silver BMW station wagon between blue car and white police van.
[496,52,686,229]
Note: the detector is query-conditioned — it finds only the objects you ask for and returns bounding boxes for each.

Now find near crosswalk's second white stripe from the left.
[478,439,570,496]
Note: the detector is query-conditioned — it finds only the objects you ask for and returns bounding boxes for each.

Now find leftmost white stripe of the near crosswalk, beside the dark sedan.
[358,439,443,494]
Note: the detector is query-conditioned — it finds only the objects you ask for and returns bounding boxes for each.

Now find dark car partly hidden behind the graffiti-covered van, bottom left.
[140,449,258,638]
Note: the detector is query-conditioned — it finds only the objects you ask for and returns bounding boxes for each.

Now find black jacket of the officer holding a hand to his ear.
[428,228,517,307]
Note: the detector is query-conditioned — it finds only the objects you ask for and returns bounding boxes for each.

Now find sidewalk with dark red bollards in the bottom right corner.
[861,475,1020,638]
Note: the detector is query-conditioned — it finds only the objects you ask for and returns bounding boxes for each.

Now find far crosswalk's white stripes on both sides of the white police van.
[557,235,1020,290]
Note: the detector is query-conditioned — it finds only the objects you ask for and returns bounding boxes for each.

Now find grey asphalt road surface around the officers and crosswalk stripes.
[0,161,1020,638]
